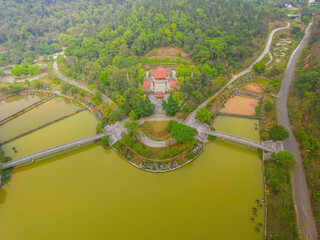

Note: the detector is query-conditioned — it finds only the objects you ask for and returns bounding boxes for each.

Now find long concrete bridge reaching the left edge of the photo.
[2,133,106,169]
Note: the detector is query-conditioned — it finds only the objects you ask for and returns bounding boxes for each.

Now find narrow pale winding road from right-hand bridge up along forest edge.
[184,23,290,126]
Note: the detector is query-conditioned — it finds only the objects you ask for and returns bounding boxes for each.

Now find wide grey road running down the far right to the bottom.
[277,19,318,240]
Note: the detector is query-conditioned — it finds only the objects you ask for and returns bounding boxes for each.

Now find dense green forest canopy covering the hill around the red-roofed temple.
[0,0,283,123]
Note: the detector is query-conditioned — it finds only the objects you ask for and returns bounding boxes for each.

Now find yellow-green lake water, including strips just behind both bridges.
[0,96,263,240]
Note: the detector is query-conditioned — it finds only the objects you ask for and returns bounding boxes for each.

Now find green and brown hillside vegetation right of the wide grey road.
[288,13,320,231]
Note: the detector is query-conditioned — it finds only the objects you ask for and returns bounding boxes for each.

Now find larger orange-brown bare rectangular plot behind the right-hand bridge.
[220,96,259,116]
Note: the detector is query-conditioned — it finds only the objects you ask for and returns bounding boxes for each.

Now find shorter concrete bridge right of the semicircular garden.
[202,130,276,152]
